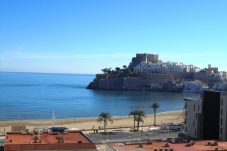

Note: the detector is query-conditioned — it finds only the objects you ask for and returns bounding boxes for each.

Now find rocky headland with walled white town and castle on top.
[88,53,227,92]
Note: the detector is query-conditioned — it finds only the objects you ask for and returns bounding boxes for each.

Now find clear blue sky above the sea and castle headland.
[0,0,227,73]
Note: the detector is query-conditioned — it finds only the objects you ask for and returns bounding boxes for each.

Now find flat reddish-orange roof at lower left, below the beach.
[5,131,92,144]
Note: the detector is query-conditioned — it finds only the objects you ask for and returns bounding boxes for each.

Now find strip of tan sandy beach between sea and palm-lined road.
[0,110,184,130]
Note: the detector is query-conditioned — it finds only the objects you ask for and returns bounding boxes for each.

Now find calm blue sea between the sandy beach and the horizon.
[0,72,198,120]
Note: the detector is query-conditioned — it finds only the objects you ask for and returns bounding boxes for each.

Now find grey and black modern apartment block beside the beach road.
[185,91,227,141]
